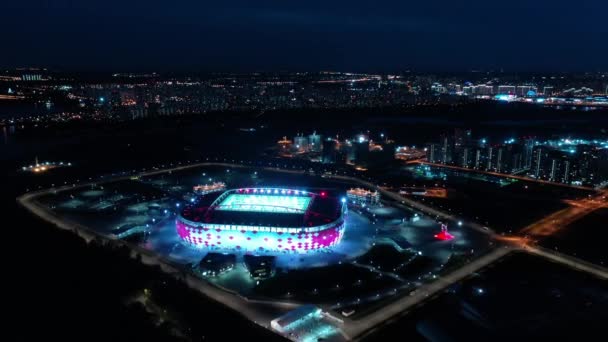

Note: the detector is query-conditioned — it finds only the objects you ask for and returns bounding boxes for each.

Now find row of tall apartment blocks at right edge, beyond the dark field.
[427,128,608,186]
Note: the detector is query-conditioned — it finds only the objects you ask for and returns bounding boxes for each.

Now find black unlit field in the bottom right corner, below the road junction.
[366,253,608,341]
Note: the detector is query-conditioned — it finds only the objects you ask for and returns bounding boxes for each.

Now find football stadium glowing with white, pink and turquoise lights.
[176,188,346,254]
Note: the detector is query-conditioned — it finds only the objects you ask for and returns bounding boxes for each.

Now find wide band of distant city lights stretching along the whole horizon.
[0,68,608,122]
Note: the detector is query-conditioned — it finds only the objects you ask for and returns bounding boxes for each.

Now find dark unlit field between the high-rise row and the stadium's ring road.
[389,167,592,232]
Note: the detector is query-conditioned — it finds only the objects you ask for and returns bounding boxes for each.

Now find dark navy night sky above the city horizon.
[0,0,608,72]
